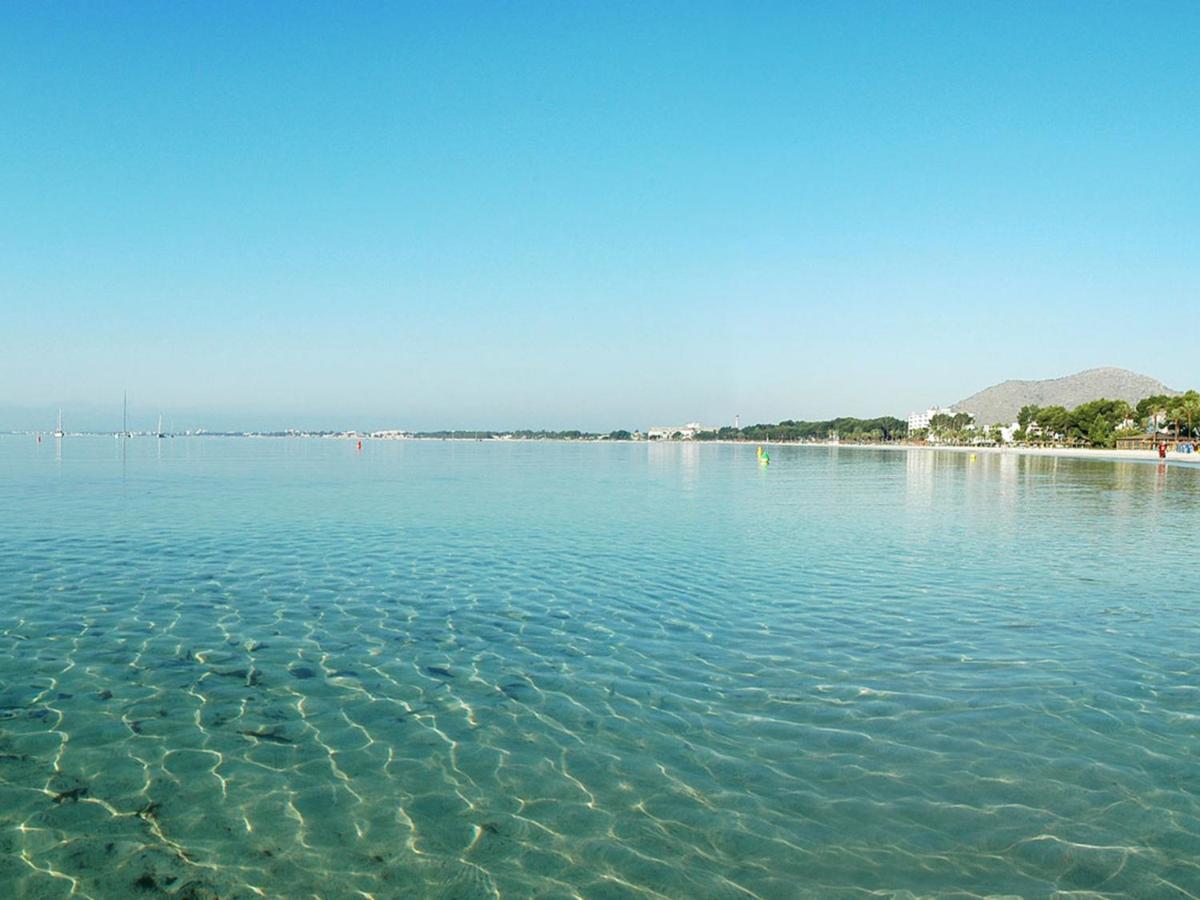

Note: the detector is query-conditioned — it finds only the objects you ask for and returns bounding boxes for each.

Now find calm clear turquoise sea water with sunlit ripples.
[0,437,1200,898]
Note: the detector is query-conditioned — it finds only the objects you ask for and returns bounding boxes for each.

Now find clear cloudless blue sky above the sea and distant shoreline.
[0,0,1200,430]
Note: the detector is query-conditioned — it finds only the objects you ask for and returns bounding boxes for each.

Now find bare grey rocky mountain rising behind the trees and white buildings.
[952,368,1178,425]
